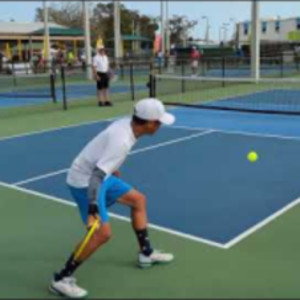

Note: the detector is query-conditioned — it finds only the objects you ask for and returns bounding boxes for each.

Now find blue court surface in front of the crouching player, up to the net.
[0,108,300,248]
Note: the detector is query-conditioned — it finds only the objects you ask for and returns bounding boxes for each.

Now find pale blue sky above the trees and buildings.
[0,1,300,40]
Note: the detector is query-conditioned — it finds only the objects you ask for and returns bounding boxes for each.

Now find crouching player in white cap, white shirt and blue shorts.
[49,98,175,298]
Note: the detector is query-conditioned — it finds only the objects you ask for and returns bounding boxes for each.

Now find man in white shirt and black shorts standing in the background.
[93,46,112,106]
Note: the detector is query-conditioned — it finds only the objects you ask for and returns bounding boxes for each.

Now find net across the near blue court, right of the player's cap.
[150,74,300,115]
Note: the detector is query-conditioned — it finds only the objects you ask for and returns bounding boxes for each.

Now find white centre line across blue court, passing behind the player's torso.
[12,130,214,186]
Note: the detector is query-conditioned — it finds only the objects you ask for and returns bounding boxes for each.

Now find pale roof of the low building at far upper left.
[0,21,67,35]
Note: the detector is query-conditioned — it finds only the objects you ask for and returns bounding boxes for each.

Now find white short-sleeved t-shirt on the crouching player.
[67,118,136,188]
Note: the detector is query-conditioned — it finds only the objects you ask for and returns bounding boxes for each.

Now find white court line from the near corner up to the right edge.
[224,198,300,249]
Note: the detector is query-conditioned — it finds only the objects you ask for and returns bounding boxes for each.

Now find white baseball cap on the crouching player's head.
[134,98,175,125]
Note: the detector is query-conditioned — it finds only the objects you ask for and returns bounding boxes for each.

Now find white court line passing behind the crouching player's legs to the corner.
[0,181,225,249]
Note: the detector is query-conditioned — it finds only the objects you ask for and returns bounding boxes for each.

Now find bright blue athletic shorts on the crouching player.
[68,175,132,224]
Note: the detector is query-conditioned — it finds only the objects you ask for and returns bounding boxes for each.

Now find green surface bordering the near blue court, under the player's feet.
[0,90,300,299]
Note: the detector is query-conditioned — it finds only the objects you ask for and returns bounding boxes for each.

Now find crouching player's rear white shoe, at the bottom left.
[49,277,88,299]
